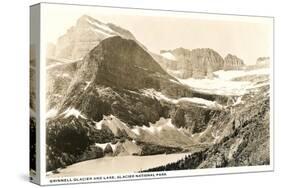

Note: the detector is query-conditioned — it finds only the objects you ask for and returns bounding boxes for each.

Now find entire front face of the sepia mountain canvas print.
[34,4,273,182]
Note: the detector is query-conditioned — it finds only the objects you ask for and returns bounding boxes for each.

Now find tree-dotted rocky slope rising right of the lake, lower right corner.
[142,74,270,171]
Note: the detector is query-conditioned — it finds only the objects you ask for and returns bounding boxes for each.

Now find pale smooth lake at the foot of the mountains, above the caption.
[47,153,189,178]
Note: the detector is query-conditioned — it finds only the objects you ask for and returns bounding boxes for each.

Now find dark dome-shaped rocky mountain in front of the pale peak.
[56,36,192,125]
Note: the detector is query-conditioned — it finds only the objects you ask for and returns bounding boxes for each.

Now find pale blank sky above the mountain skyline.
[41,4,273,64]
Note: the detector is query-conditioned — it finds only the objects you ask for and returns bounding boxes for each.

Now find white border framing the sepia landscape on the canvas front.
[37,3,275,185]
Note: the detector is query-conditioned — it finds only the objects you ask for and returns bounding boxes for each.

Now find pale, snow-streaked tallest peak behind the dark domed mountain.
[54,15,135,60]
